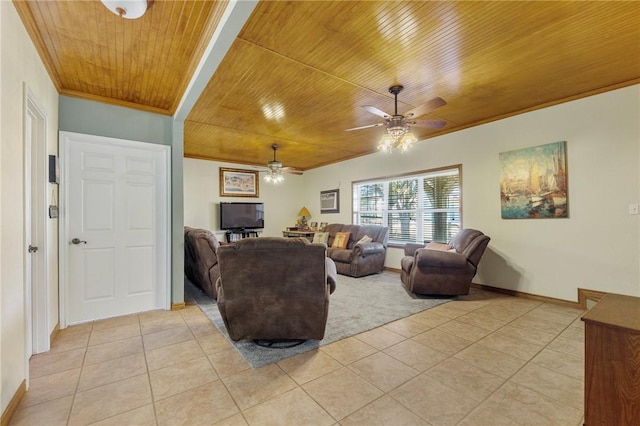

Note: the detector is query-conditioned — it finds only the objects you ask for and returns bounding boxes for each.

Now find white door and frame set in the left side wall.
[23,83,51,362]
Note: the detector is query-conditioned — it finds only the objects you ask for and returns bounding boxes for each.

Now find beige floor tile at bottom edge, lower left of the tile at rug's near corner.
[155,380,239,426]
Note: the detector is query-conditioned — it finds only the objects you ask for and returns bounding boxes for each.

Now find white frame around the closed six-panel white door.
[58,131,171,329]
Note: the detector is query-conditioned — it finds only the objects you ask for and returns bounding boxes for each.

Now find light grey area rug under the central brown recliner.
[185,271,452,368]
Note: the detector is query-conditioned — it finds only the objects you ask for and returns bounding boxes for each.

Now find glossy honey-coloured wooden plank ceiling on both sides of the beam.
[14,0,640,170]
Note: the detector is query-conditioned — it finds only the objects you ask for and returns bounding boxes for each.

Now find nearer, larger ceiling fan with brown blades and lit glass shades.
[346,84,447,151]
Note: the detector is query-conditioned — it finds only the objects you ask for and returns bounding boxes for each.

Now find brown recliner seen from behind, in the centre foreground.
[216,237,336,341]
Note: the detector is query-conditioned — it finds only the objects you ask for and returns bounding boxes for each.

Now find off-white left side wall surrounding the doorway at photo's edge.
[0,1,58,412]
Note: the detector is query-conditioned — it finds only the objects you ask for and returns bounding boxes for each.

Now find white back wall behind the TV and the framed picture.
[184,158,306,241]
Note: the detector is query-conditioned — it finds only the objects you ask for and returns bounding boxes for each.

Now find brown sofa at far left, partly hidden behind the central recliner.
[184,226,220,299]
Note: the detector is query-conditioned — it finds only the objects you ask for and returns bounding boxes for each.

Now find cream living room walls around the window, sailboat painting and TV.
[184,86,640,301]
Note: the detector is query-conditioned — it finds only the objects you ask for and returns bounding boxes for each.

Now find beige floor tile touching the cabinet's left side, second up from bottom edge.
[510,364,584,411]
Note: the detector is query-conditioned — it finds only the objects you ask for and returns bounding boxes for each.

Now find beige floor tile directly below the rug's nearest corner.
[222,365,297,410]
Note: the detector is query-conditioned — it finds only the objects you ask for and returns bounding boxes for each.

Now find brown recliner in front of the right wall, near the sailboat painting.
[400,229,490,296]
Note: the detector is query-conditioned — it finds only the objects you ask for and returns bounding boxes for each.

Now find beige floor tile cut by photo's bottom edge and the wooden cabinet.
[483,382,582,426]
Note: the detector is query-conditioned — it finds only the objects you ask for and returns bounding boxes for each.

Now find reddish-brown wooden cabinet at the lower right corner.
[582,294,640,426]
